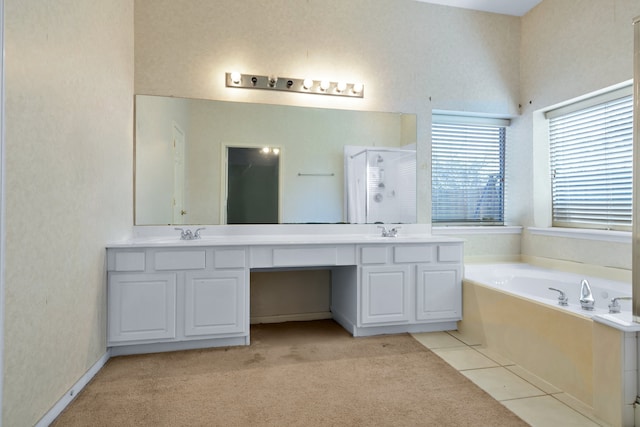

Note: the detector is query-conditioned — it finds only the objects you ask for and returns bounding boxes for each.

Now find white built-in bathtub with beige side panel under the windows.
[458,264,635,416]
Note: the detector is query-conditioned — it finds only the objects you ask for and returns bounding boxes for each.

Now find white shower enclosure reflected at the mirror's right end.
[344,146,416,224]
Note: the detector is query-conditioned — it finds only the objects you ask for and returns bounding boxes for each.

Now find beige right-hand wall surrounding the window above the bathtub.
[508,0,640,269]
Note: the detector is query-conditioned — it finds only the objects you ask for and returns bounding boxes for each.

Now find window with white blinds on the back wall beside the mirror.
[431,115,509,225]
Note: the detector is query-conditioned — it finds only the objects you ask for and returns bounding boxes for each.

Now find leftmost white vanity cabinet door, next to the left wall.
[108,274,176,342]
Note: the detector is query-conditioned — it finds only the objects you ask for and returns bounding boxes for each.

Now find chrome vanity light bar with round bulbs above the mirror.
[225,72,364,98]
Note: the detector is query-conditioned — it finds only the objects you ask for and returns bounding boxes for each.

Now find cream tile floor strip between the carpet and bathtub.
[412,331,606,427]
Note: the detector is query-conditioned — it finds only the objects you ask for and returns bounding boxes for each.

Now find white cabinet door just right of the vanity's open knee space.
[361,266,409,324]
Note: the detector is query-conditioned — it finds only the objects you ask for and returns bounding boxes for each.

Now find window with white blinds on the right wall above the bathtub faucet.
[546,88,633,230]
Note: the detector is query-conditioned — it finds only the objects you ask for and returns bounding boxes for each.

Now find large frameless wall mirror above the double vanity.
[135,95,416,225]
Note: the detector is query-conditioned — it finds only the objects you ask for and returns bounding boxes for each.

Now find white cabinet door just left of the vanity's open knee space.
[184,271,246,336]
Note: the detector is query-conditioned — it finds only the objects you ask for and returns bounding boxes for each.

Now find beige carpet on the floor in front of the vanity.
[53,320,527,427]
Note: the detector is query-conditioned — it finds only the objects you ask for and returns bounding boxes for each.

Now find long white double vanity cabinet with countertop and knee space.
[107,229,463,355]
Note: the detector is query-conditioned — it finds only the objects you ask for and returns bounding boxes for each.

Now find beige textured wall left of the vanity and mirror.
[3,0,133,426]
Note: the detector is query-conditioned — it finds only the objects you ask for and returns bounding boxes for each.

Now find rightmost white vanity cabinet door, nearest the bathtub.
[416,266,462,320]
